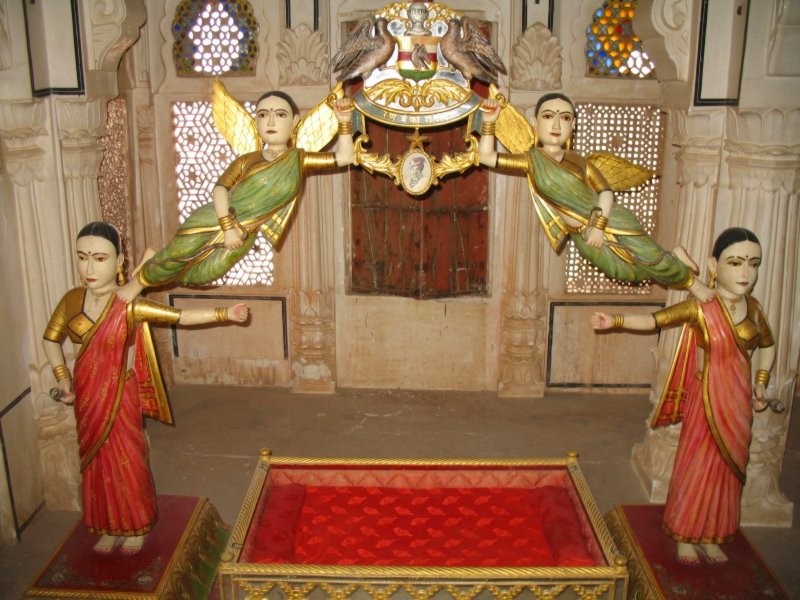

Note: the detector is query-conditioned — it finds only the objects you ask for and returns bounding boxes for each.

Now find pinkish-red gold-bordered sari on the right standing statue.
[653,300,753,544]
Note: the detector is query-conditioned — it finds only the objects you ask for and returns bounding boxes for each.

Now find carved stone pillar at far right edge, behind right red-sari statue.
[717,109,800,527]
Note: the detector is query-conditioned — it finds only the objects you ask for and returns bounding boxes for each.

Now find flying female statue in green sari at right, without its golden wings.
[478,93,713,300]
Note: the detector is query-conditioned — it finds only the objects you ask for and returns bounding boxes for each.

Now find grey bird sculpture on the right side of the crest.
[439,18,506,83]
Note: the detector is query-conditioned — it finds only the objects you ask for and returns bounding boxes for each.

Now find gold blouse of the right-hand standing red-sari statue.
[653,296,775,352]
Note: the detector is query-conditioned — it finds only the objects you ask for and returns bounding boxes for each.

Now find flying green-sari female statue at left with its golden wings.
[120,81,354,300]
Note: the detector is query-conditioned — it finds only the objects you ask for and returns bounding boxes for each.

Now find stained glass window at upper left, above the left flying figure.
[172,0,258,76]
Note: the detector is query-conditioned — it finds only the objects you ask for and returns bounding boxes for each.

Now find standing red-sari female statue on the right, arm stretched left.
[592,227,775,565]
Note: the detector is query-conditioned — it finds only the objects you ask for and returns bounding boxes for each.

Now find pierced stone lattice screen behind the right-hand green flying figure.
[565,103,664,294]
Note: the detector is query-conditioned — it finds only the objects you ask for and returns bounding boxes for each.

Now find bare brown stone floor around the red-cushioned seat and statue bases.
[0,386,800,598]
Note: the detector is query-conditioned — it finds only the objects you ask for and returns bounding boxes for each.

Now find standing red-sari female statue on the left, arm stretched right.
[43,221,248,554]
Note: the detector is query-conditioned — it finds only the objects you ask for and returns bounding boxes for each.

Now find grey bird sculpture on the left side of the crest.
[332,16,395,81]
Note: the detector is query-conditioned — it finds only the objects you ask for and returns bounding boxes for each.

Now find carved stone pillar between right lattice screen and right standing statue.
[632,109,725,502]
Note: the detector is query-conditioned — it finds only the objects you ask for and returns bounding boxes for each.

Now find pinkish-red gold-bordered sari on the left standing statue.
[73,299,169,536]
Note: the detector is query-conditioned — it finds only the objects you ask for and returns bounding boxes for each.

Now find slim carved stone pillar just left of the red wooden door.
[289,175,336,394]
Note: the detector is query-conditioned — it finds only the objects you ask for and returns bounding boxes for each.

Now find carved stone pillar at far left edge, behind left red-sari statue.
[0,100,80,510]
